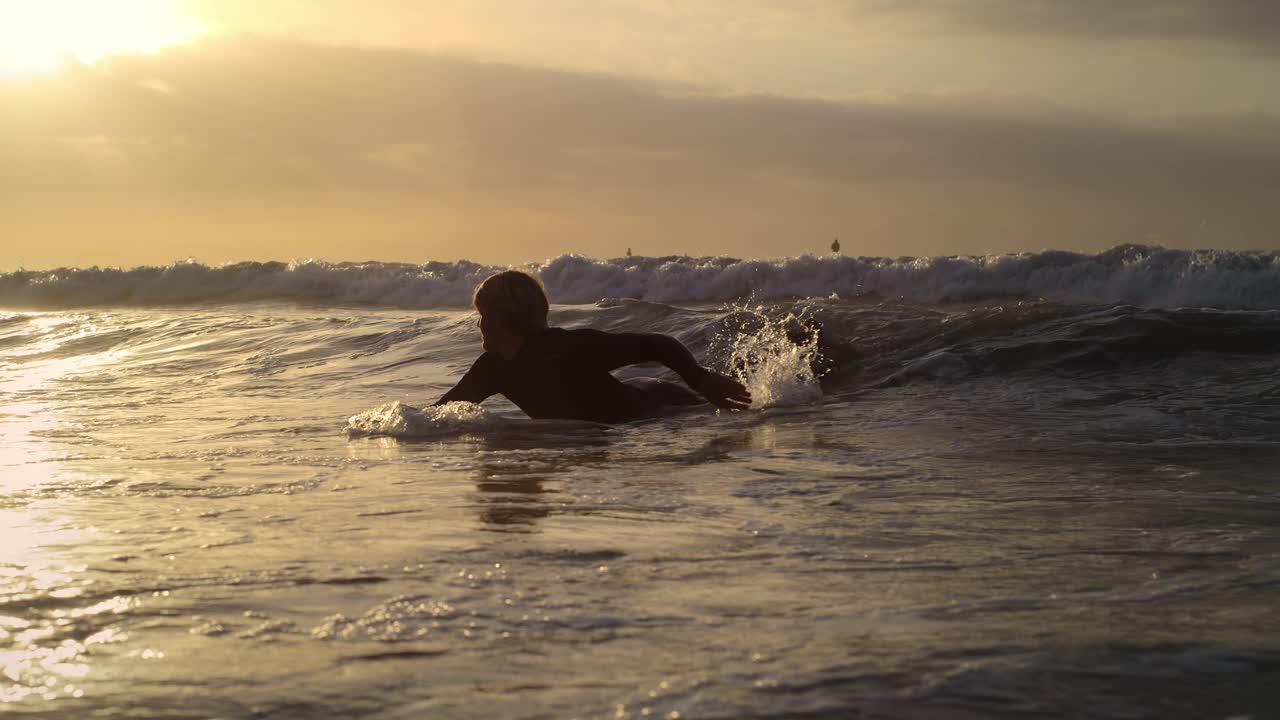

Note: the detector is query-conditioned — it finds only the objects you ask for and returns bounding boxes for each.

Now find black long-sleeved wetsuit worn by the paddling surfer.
[436,328,707,423]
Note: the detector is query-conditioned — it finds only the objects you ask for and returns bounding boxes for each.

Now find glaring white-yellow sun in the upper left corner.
[0,0,201,77]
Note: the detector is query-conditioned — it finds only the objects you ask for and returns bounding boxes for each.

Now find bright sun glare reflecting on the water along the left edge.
[0,314,132,707]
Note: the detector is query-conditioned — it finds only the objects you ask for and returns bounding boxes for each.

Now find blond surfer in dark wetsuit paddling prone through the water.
[435,270,751,423]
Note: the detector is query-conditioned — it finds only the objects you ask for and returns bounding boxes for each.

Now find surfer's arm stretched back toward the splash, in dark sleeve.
[571,328,751,410]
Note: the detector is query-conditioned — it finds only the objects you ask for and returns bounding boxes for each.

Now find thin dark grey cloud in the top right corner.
[840,0,1280,54]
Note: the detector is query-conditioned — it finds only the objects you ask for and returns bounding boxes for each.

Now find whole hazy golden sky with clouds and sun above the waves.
[0,0,1280,269]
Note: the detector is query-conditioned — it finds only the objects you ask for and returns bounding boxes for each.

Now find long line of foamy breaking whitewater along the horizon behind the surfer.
[0,245,1280,309]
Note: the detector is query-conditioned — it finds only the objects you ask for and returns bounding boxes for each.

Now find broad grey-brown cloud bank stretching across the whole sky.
[0,38,1280,192]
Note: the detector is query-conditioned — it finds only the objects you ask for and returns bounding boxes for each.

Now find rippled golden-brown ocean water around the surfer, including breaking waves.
[0,246,1280,720]
